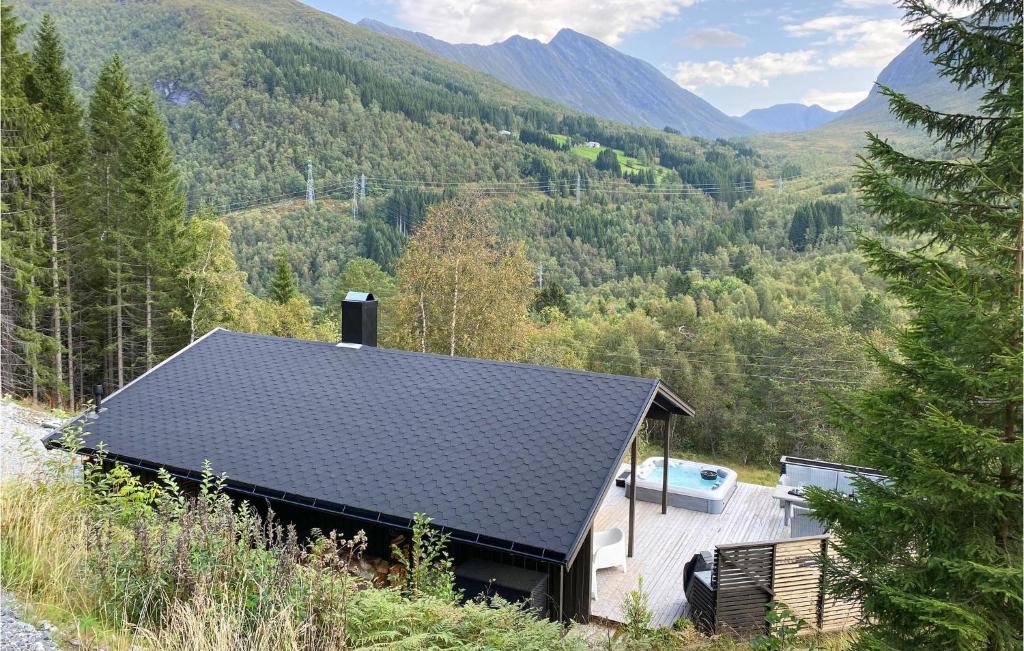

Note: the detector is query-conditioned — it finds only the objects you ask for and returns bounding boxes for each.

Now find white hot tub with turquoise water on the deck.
[626,457,736,513]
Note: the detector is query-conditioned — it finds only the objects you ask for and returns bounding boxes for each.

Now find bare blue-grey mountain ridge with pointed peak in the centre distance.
[358,19,754,138]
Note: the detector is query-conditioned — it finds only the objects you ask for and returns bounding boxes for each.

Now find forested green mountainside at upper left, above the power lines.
[15,0,741,208]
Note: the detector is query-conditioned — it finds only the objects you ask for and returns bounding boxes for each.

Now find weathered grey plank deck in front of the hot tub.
[591,472,788,626]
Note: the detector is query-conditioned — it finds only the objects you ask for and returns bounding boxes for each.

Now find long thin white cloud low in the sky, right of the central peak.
[673,50,821,90]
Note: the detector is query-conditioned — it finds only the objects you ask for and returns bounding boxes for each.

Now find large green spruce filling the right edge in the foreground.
[811,0,1024,649]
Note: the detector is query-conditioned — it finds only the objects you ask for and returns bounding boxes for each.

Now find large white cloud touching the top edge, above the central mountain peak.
[395,0,697,45]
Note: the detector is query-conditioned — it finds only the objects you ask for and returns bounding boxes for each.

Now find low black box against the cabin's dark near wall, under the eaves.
[455,559,549,617]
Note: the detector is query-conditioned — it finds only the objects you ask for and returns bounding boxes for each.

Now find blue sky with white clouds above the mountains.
[304,0,911,116]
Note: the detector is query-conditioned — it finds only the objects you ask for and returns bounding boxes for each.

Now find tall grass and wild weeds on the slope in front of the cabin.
[0,429,585,651]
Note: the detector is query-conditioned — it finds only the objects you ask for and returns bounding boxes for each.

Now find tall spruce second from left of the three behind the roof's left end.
[89,54,134,387]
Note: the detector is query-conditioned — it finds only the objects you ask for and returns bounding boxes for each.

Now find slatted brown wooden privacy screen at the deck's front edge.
[690,535,860,637]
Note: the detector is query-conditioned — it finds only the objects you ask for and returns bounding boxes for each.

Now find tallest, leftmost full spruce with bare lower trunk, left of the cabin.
[28,14,87,408]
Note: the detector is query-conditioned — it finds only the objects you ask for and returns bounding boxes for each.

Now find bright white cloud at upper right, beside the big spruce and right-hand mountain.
[784,14,910,69]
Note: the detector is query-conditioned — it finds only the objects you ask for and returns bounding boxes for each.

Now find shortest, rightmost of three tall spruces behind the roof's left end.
[123,90,184,370]
